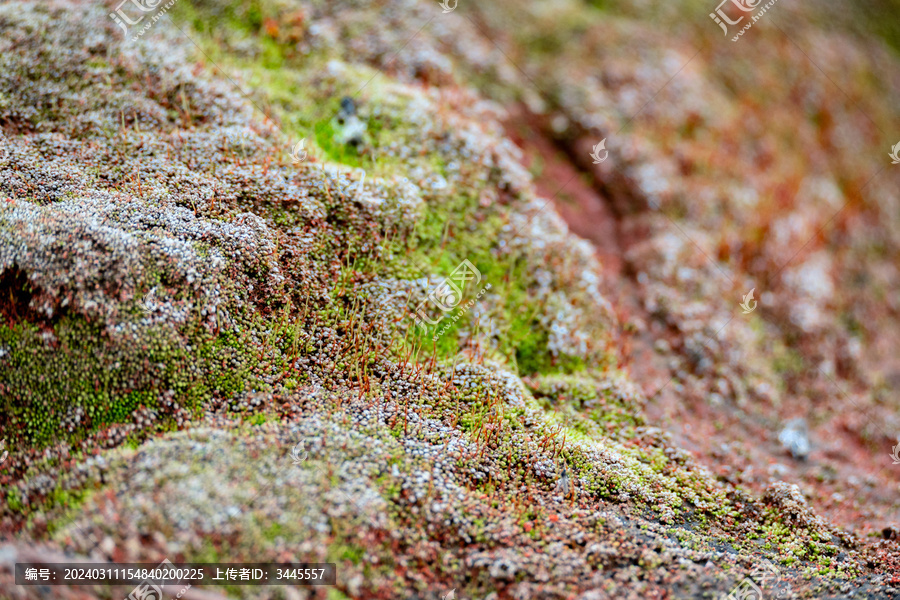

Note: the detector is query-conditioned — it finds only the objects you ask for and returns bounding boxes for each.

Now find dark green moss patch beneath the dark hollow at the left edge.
[0,308,268,448]
